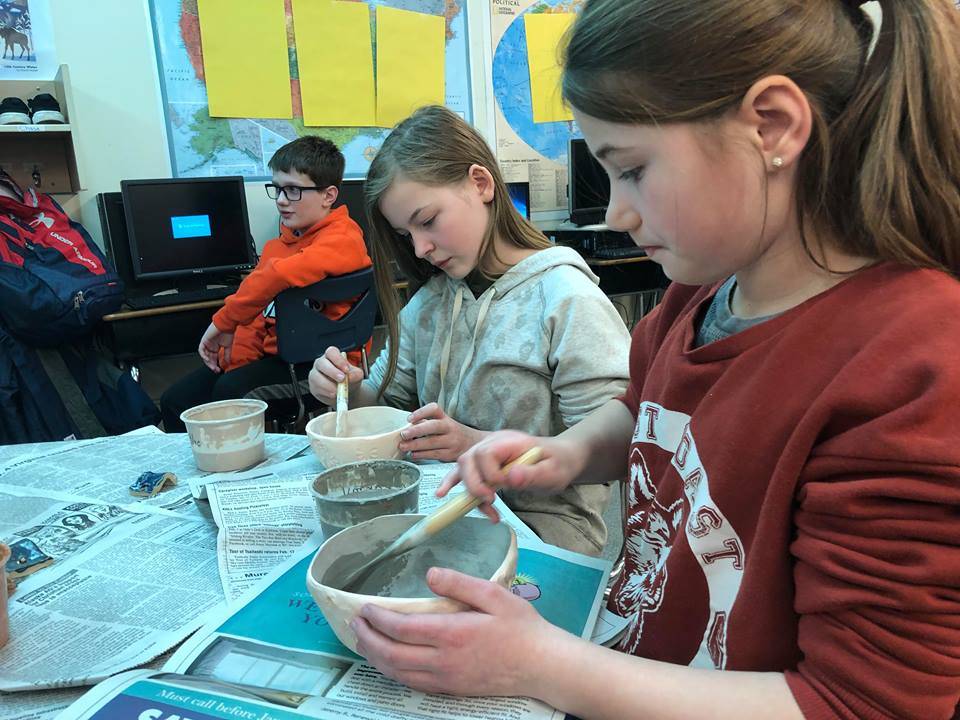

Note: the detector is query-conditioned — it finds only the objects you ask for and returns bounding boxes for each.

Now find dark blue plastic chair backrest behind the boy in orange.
[276,267,377,365]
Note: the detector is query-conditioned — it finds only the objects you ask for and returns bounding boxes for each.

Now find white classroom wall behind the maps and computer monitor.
[50,0,493,253]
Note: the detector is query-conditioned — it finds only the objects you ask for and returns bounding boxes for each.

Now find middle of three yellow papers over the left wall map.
[293,0,377,127]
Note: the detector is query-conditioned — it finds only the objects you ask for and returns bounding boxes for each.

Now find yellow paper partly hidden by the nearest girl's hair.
[523,13,576,123]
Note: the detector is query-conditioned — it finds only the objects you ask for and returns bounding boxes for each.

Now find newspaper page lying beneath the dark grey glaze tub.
[207,456,537,603]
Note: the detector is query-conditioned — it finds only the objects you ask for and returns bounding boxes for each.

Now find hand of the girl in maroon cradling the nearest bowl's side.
[351,568,572,696]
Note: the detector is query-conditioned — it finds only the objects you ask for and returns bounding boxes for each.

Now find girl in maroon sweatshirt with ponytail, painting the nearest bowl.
[355,0,960,720]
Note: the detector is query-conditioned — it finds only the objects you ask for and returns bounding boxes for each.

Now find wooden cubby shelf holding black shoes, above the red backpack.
[0,65,83,193]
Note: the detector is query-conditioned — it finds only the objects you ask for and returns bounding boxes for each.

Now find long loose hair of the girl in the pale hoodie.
[364,105,550,397]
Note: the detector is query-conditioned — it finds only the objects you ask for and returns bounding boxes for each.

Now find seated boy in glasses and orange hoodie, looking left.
[160,135,371,432]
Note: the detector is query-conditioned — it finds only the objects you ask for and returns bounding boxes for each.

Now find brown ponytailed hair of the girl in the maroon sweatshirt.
[563,0,960,276]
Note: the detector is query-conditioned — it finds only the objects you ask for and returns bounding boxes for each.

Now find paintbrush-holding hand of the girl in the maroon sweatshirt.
[437,430,584,522]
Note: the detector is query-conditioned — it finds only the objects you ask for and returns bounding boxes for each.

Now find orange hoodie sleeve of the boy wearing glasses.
[213,216,372,332]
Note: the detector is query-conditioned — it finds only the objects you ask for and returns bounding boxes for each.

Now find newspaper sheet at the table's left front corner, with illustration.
[0,496,224,691]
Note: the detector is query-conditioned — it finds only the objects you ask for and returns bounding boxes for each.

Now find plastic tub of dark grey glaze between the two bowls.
[310,460,420,538]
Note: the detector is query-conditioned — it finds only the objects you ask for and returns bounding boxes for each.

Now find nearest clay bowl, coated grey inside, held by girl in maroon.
[307,515,517,652]
